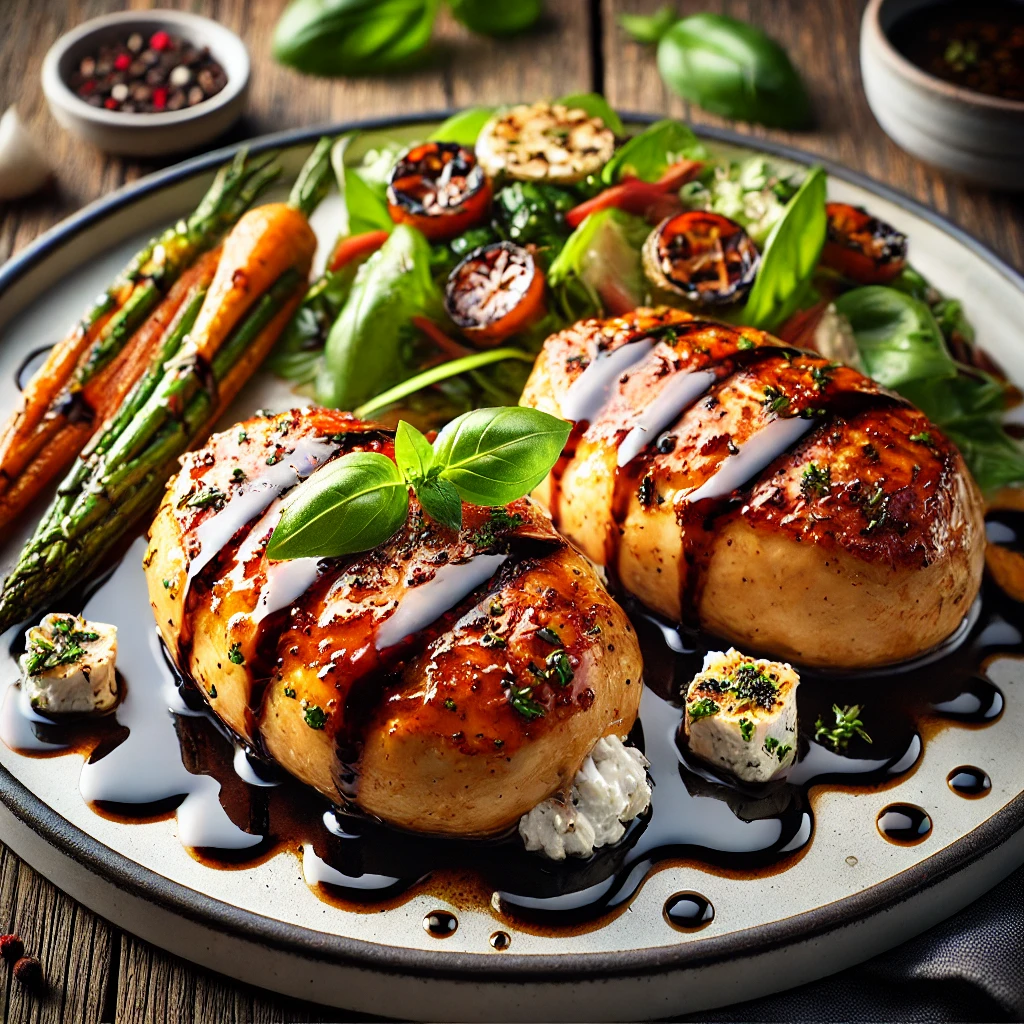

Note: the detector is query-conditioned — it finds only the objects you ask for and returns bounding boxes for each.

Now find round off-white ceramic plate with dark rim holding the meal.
[0,115,1024,1020]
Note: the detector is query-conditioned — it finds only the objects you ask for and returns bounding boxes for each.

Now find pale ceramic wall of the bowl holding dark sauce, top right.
[860,0,1024,190]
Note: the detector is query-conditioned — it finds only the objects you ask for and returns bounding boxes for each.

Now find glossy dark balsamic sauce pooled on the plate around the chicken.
[0,511,1024,933]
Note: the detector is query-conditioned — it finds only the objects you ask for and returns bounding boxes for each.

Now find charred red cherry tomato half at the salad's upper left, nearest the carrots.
[387,142,492,242]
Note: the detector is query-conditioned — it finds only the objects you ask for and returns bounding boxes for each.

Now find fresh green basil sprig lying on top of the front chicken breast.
[266,407,569,560]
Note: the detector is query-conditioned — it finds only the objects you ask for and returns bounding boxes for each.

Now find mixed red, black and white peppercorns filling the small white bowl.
[68,30,227,114]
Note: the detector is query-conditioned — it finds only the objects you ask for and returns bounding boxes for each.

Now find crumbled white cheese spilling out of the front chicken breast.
[519,736,650,860]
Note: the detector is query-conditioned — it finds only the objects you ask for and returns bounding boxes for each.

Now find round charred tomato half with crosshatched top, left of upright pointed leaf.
[643,210,761,306]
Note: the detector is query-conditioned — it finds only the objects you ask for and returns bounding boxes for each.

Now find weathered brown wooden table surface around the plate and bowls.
[0,0,1024,1024]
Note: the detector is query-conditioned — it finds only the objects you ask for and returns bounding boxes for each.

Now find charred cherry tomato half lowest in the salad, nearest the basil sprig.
[444,242,545,346]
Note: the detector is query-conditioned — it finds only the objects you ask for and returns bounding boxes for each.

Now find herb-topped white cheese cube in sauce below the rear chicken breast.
[683,648,800,782]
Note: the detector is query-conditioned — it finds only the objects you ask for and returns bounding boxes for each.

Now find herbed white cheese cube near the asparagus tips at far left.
[19,614,118,715]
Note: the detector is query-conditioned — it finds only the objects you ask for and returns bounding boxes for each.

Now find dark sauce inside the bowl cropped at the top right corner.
[889,0,1024,100]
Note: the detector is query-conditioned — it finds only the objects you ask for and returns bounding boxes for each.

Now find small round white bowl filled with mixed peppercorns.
[42,10,249,157]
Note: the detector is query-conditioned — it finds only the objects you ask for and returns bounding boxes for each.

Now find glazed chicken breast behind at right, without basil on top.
[522,309,984,668]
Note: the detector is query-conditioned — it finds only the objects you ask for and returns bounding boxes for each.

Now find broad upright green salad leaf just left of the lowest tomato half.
[316,224,442,409]
